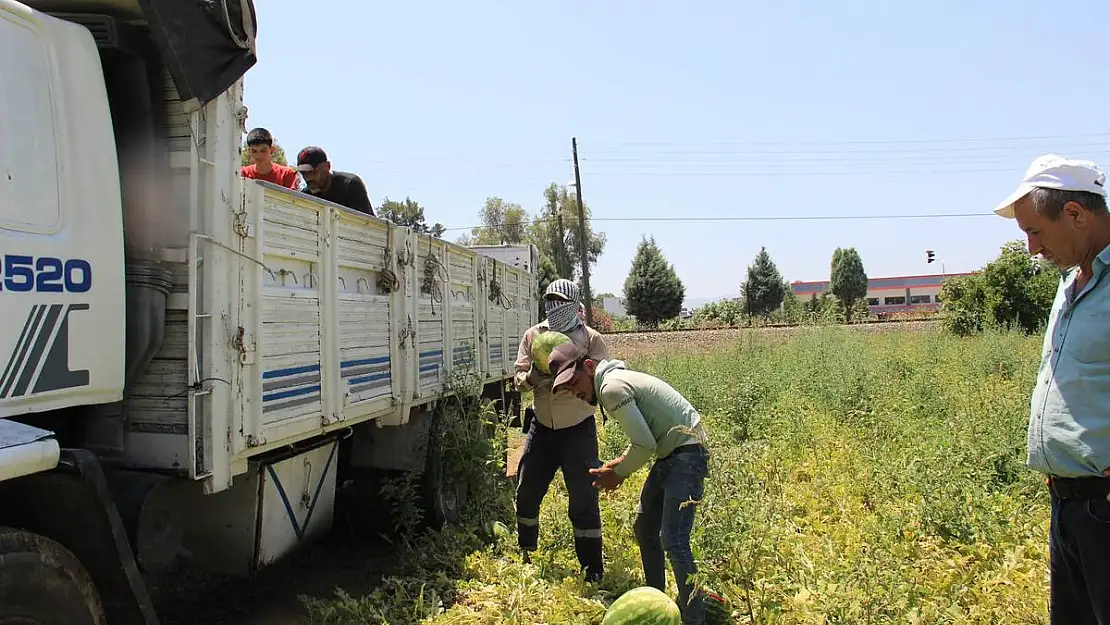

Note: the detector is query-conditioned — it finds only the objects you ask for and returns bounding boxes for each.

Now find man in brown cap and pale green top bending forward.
[548,344,709,625]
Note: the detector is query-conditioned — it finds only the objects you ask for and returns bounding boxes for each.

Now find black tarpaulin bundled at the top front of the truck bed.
[139,0,258,109]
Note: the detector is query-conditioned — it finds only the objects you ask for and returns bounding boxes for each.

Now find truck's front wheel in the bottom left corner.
[0,527,104,625]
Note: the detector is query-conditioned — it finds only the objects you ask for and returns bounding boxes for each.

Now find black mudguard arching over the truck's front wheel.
[0,450,159,625]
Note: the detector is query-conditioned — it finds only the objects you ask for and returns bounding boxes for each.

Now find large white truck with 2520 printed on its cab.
[0,0,538,625]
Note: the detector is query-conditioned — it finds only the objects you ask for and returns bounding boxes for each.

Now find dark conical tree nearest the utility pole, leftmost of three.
[624,238,686,327]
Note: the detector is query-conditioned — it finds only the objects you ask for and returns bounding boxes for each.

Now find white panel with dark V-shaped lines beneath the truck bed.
[254,440,339,569]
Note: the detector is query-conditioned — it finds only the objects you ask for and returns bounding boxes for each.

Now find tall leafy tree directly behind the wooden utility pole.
[528,183,608,280]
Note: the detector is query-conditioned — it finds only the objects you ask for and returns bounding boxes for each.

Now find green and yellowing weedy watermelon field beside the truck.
[305,327,1049,625]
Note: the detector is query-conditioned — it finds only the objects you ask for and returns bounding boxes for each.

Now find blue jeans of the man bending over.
[635,445,709,625]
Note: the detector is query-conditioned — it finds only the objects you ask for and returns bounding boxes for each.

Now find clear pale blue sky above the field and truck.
[240,0,1110,306]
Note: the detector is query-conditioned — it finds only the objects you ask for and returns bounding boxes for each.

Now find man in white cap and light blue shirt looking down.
[995,154,1110,625]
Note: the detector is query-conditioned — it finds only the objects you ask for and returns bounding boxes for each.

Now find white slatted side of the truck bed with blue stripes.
[232,181,535,465]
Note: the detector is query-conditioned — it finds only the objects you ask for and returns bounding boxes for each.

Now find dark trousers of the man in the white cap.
[1049,495,1110,625]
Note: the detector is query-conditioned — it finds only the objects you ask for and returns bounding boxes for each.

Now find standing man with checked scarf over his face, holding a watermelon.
[514,280,608,582]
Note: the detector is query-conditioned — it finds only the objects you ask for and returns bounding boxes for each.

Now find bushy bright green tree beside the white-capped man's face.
[939,241,1061,335]
